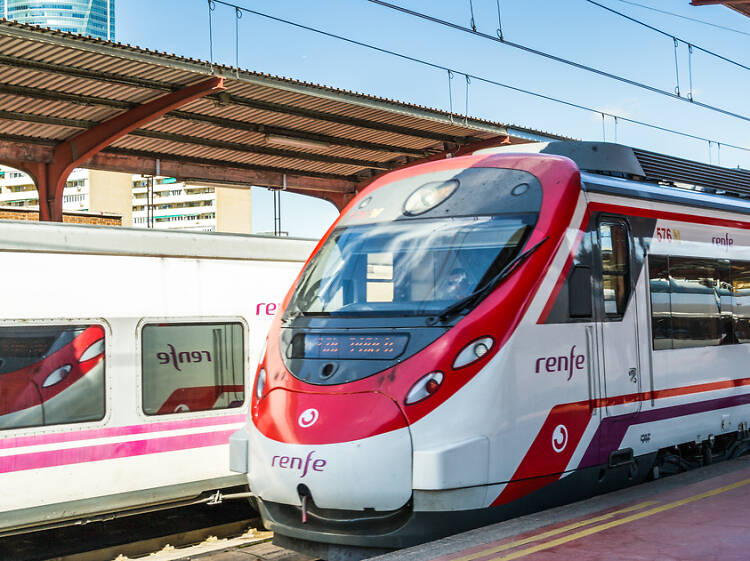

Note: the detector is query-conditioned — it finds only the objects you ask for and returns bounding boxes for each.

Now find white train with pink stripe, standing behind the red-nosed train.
[0,221,314,536]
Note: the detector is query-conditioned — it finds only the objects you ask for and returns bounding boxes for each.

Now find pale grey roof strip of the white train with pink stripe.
[0,220,316,262]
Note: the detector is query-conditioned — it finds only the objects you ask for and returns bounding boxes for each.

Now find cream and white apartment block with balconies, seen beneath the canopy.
[0,166,252,234]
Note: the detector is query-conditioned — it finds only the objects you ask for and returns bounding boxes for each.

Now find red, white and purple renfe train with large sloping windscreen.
[230,141,750,559]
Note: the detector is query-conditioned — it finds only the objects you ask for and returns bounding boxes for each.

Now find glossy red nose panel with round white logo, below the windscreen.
[255,388,406,444]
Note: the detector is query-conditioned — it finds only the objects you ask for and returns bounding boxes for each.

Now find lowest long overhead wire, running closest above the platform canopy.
[209,0,750,156]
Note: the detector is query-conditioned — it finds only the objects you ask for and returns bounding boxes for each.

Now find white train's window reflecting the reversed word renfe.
[141,323,245,415]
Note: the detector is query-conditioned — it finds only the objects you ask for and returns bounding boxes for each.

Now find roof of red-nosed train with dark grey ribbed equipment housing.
[475,141,750,214]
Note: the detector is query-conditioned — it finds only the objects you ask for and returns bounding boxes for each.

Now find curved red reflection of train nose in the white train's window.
[0,325,104,415]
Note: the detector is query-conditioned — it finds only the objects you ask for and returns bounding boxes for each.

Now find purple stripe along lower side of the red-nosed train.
[578,393,750,468]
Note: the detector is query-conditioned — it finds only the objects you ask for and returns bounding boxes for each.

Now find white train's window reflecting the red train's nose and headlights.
[0,325,105,429]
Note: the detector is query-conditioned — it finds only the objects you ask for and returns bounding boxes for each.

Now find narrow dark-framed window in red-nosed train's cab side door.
[599,221,630,319]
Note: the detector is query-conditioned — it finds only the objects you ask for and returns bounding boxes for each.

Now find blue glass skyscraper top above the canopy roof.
[0,0,115,41]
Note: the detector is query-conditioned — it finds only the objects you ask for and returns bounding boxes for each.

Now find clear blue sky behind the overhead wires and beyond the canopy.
[116,0,750,237]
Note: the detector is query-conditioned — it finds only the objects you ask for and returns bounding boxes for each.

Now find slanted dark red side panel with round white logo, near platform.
[492,401,591,506]
